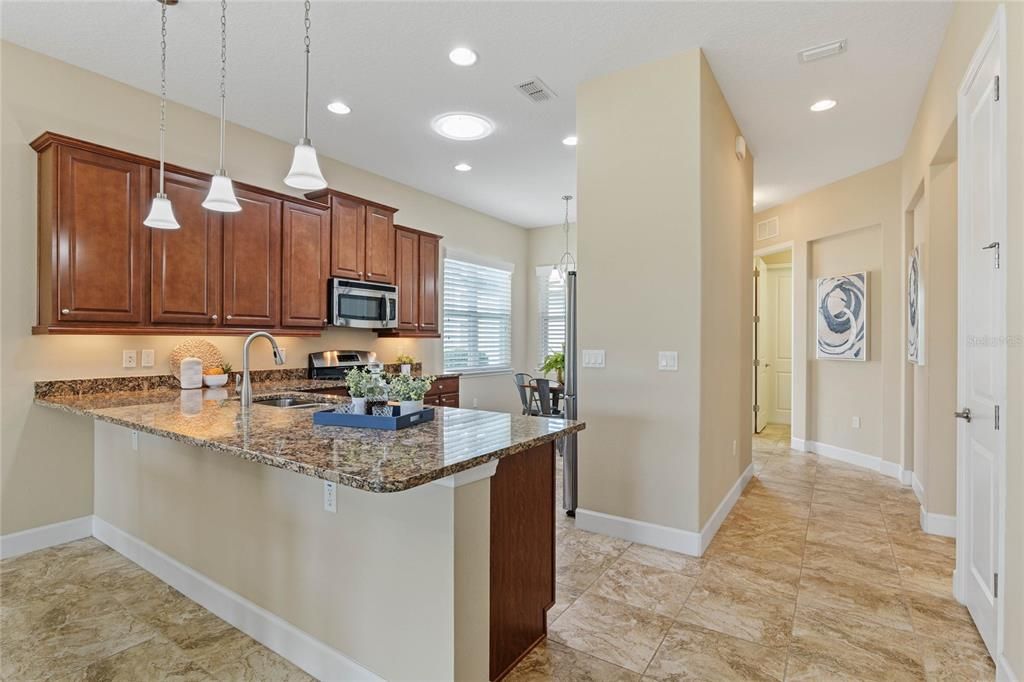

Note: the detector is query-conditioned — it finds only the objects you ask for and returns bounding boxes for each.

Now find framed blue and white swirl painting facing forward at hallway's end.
[817,272,867,361]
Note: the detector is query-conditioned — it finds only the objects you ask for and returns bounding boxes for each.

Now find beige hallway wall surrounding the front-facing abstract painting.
[754,162,903,462]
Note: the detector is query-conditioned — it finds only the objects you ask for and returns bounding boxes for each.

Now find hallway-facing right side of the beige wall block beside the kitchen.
[698,54,754,527]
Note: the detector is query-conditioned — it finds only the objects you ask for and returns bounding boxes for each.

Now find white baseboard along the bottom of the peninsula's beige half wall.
[92,517,381,680]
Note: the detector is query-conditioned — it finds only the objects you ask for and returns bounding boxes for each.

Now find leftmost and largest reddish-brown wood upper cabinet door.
[55,147,148,323]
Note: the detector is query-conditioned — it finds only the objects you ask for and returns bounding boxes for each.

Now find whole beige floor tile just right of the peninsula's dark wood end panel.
[548,594,672,673]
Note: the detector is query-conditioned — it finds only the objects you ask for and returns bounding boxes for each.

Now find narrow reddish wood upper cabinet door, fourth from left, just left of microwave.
[281,202,331,327]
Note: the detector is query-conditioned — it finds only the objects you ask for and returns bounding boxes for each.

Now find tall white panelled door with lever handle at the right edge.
[956,12,1007,658]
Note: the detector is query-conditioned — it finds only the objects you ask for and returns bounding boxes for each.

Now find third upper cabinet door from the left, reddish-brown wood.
[221,184,282,327]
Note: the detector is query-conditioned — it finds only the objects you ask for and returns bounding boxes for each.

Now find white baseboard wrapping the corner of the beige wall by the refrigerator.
[575,464,754,556]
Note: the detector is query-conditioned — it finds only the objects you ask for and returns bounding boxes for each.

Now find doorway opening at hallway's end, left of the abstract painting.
[752,245,793,434]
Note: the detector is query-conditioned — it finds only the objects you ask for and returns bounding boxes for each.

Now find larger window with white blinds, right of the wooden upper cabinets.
[443,250,512,373]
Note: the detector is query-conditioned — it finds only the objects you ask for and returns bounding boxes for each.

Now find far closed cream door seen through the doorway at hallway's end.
[764,265,793,424]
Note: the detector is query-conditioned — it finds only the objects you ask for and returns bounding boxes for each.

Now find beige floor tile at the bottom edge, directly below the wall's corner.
[644,624,786,682]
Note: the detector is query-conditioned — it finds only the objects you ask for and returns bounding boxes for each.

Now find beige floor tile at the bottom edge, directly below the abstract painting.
[785,606,925,682]
